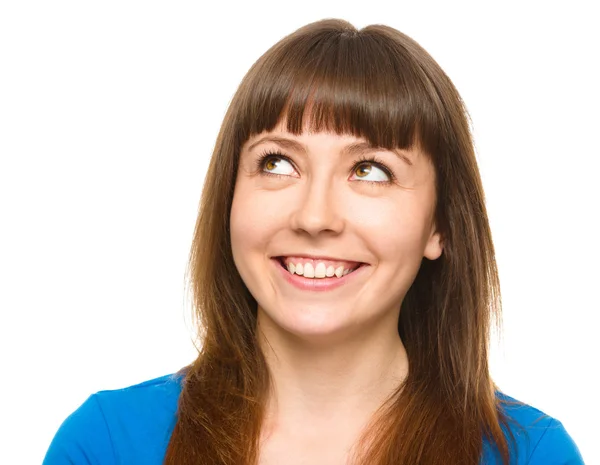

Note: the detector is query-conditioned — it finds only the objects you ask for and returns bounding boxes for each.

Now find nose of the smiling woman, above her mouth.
[291,177,345,236]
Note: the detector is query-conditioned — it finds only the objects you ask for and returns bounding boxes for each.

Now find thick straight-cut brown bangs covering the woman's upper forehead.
[234,26,443,155]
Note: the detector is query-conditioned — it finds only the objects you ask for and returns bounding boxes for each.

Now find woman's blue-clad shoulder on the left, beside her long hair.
[43,374,182,465]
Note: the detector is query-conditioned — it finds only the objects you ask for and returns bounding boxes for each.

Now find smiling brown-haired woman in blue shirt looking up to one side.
[44,20,583,465]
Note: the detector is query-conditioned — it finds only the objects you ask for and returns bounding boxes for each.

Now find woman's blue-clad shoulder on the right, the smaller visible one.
[488,392,584,465]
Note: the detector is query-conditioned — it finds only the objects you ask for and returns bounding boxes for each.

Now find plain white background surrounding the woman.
[0,0,600,464]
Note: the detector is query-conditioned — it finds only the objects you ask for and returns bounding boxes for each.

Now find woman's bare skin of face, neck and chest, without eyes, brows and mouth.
[230,118,443,465]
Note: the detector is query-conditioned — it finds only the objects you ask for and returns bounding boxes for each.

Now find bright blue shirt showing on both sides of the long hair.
[42,375,583,465]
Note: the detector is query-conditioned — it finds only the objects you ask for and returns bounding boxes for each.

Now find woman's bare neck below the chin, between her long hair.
[258,312,408,429]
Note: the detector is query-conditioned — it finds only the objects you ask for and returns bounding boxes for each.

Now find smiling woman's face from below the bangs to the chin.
[230,119,442,339]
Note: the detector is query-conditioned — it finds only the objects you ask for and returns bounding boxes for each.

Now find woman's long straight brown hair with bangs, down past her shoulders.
[164,19,514,465]
